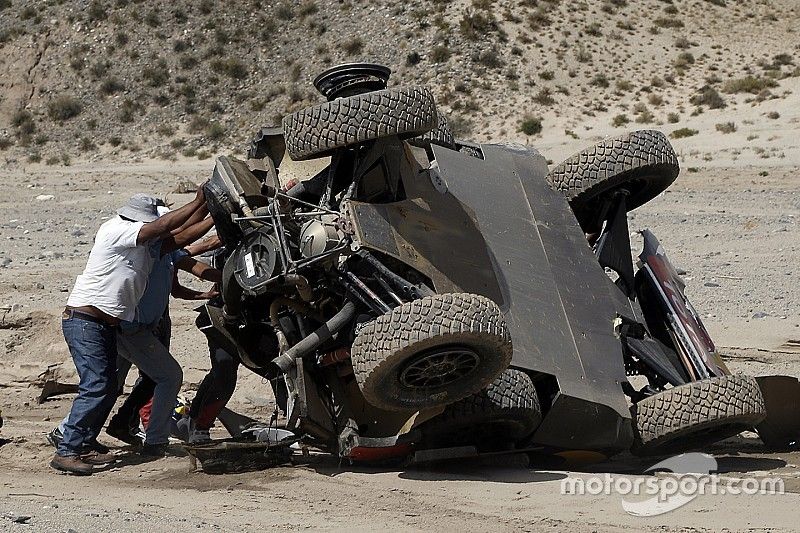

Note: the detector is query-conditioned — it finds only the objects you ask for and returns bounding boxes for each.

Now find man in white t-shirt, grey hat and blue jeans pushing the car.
[50,187,210,475]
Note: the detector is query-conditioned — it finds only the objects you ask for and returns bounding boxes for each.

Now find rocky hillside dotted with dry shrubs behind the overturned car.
[0,0,800,165]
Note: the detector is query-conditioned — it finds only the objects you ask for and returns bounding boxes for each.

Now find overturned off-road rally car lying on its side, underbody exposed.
[197,64,796,466]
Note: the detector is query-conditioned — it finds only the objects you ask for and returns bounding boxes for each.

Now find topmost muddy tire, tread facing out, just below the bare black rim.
[283,86,436,161]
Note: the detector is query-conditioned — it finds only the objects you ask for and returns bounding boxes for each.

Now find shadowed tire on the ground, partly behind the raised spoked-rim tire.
[419,368,542,450]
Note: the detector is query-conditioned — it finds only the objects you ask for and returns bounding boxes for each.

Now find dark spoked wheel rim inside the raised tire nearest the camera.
[400,346,480,389]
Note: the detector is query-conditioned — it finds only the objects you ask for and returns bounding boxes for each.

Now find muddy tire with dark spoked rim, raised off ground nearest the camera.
[351,293,512,411]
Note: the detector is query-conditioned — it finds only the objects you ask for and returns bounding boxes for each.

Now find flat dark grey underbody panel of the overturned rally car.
[350,139,635,451]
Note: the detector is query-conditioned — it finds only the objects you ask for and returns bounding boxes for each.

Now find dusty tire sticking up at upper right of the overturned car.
[547,130,680,227]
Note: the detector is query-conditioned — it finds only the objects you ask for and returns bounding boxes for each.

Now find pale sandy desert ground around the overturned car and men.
[0,152,800,532]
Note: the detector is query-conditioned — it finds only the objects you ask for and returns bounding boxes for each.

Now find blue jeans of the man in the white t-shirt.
[56,317,117,457]
